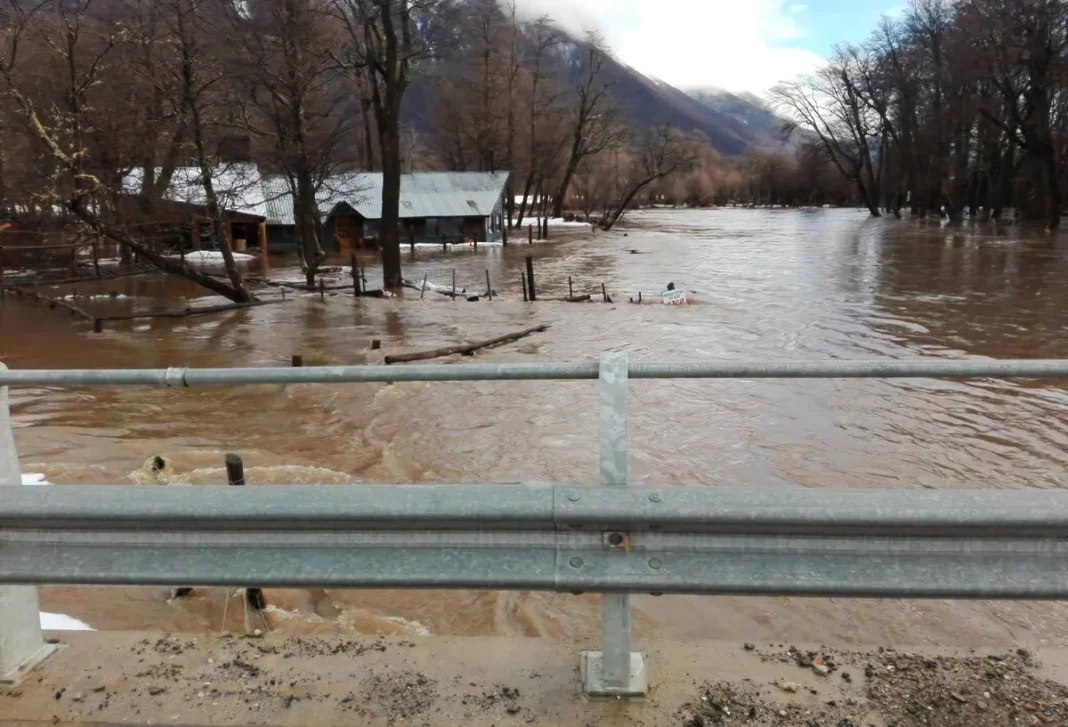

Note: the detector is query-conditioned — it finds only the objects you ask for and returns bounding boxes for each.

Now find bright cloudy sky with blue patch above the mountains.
[516,0,904,94]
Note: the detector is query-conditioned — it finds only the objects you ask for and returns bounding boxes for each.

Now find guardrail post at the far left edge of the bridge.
[0,363,56,684]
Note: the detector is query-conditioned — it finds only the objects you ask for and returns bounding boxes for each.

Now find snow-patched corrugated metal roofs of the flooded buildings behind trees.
[123,164,508,225]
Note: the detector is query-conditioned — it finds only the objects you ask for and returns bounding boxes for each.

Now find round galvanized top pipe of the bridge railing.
[0,359,1068,386]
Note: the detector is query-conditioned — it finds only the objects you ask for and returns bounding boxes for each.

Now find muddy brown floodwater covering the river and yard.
[0,210,1068,646]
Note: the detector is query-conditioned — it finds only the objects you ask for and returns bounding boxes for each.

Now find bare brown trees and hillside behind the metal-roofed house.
[0,0,707,294]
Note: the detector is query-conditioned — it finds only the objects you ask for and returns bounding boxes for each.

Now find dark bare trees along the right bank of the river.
[771,0,1068,228]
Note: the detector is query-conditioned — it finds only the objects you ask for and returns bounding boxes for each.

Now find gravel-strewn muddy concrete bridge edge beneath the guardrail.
[6,632,1068,727]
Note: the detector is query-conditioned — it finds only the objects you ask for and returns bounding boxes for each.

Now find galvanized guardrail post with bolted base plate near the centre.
[581,352,646,696]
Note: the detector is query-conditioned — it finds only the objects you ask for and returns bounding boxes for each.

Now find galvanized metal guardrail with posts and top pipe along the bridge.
[0,353,1068,695]
